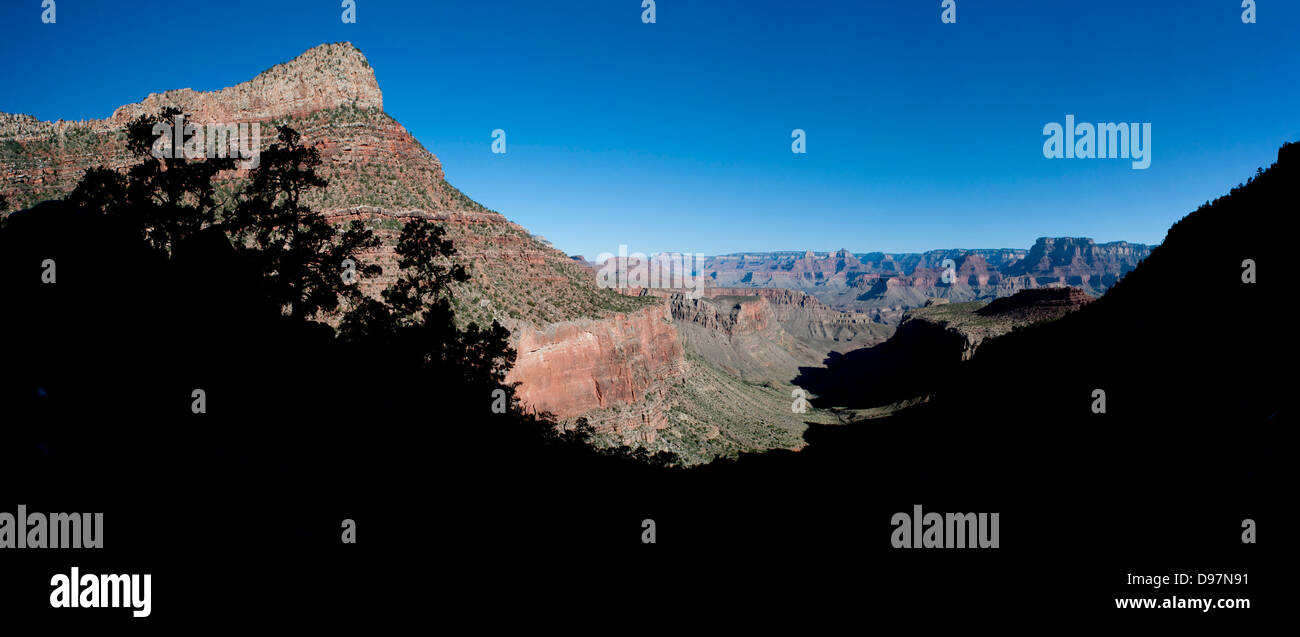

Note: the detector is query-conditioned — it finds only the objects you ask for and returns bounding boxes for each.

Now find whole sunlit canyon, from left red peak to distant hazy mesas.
[0,43,1151,464]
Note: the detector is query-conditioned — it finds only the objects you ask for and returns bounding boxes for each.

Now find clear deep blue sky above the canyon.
[0,0,1300,257]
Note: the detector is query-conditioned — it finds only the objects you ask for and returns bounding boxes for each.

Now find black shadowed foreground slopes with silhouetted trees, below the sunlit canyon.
[0,126,1300,625]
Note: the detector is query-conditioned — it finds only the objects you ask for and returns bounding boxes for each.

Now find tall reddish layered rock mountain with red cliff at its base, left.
[0,43,681,428]
